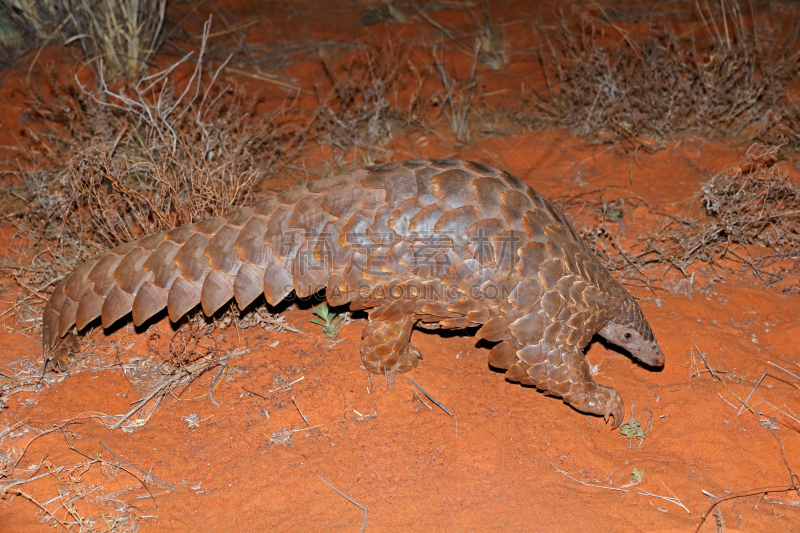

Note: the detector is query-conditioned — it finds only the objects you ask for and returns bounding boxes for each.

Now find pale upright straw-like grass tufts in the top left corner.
[0,0,167,80]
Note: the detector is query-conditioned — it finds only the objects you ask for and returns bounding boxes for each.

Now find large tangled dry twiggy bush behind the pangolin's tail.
[0,21,305,308]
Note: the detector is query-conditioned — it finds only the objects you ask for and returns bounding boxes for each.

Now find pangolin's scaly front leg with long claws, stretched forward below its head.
[506,343,625,429]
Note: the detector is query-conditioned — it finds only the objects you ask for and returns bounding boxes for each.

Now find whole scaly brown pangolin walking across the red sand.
[42,159,664,427]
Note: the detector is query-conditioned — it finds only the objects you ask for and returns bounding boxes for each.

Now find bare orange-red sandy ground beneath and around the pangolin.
[0,1,800,532]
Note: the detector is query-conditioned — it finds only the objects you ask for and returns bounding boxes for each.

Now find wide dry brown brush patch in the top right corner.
[517,0,800,149]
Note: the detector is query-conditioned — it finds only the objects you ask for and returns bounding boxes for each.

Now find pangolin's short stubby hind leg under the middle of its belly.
[361,305,421,374]
